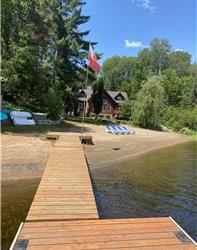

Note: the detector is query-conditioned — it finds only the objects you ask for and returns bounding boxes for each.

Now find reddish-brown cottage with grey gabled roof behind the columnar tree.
[77,86,128,118]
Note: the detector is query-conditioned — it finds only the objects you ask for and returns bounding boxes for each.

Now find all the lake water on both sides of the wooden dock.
[1,142,197,250]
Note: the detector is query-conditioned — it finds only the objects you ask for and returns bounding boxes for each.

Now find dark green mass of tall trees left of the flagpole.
[1,0,94,118]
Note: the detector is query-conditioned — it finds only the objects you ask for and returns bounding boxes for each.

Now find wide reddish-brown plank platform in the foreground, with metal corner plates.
[16,217,196,250]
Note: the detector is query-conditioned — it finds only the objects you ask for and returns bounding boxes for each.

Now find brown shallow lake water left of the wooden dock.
[1,179,40,250]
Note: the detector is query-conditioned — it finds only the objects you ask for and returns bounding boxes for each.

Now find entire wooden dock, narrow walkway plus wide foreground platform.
[10,133,197,250]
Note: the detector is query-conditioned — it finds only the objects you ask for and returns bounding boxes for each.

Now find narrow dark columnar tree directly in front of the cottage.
[92,78,104,120]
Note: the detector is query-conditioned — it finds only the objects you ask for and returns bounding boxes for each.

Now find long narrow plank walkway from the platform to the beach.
[26,133,99,221]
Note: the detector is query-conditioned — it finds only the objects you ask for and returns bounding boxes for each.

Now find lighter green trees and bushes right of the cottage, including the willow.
[103,39,197,134]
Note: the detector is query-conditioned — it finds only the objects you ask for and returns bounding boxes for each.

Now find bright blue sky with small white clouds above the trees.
[81,0,197,63]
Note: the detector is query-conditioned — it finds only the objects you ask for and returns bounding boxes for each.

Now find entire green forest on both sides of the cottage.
[1,0,197,134]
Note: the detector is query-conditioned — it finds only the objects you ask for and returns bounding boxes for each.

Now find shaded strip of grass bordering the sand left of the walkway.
[1,121,73,134]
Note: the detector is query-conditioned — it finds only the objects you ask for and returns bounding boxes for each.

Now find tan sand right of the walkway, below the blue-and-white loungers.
[81,125,192,168]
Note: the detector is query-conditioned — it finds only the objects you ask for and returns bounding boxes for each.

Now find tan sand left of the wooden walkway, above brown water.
[1,134,52,180]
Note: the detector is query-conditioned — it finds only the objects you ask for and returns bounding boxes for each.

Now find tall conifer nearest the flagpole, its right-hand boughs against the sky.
[42,0,90,117]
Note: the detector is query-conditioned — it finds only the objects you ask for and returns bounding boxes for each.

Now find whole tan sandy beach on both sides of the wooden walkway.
[1,122,192,180]
